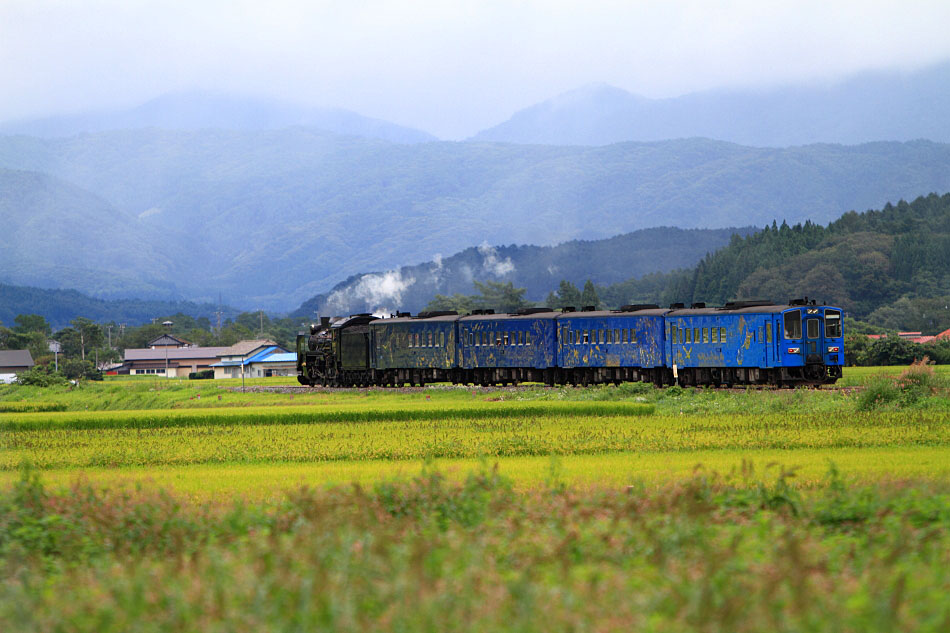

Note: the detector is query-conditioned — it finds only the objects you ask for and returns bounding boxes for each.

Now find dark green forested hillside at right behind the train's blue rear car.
[601,194,950,332]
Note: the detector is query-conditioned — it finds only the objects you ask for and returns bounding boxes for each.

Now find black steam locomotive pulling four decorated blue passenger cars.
[296,298,844,387]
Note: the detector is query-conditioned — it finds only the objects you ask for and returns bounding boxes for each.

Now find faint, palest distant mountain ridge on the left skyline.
[0,91,436,143]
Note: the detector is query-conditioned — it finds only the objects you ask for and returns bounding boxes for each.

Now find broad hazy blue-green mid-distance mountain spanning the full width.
[0,128,950,310]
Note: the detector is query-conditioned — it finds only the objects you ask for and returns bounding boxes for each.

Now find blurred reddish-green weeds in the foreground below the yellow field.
[0,467,950,633]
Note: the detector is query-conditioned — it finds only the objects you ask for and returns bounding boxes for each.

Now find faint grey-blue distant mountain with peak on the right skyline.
[473,64,950,147]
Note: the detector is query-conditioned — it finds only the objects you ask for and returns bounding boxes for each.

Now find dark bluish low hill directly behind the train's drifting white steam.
[291,227,755,319]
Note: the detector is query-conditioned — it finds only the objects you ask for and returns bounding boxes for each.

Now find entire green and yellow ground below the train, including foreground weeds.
[0,368,950,631]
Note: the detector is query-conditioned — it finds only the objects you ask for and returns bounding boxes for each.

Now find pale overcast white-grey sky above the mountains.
[0,0,950,138]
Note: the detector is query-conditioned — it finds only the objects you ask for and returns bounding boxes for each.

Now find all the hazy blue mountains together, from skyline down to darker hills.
[0,66,950,311]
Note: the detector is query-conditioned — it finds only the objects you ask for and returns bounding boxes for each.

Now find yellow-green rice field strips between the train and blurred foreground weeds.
[0,368,950,499]
